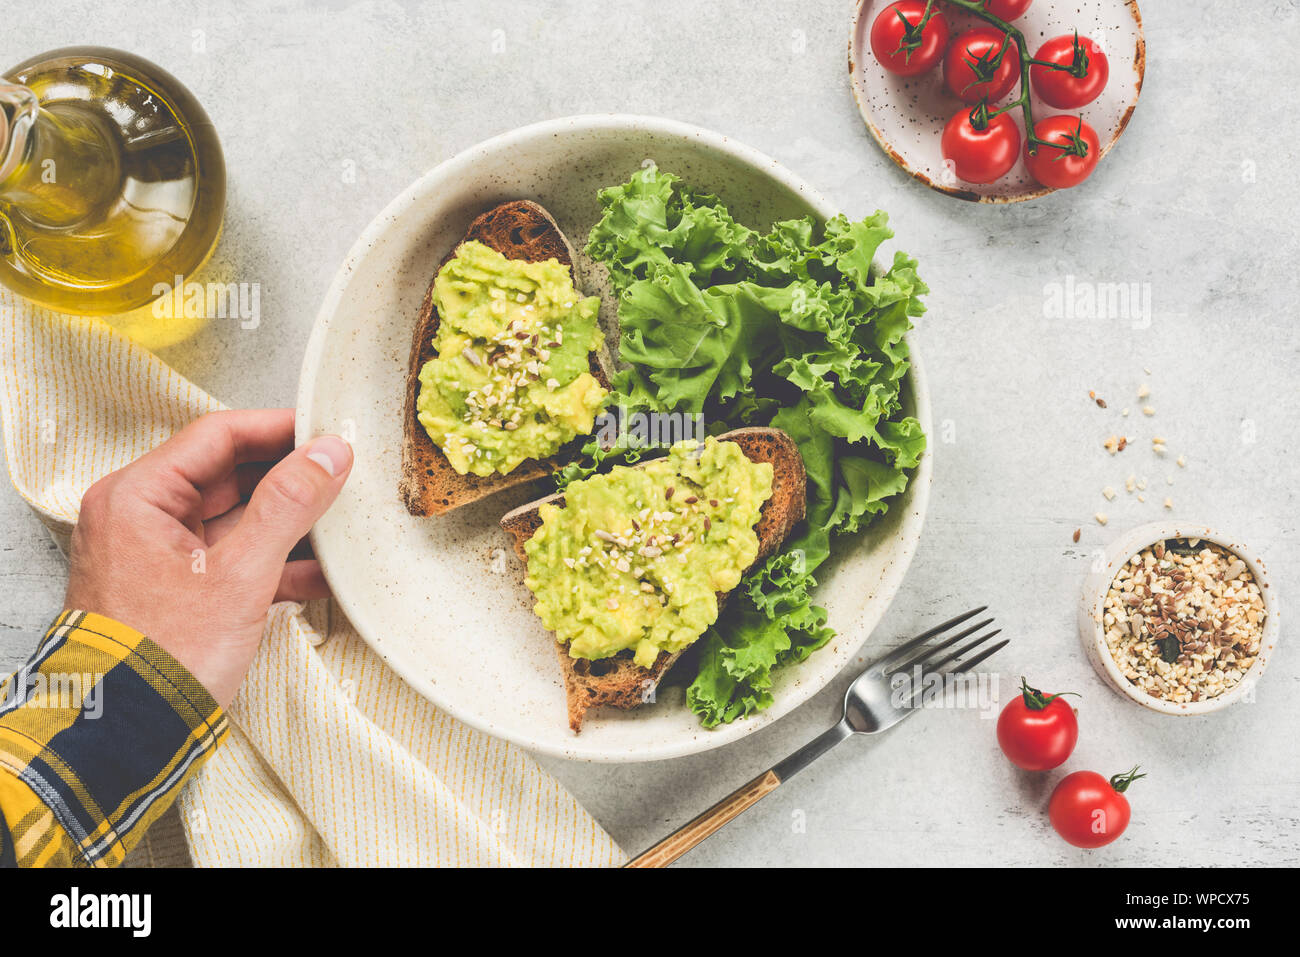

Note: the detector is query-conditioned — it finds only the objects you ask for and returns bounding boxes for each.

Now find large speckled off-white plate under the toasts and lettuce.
[298,116,931,761]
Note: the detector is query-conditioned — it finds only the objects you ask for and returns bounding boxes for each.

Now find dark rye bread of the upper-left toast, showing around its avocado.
[398,199,610,515]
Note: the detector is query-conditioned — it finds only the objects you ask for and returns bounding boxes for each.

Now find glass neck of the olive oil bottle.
[0,83,120,226]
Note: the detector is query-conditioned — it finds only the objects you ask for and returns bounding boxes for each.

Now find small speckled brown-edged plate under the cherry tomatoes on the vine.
[849,0,1147,203]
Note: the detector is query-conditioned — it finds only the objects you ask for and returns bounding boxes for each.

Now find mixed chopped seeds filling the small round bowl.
[1102,538,1266,702]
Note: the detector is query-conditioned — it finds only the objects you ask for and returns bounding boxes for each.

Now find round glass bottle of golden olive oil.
[0,47,226,321]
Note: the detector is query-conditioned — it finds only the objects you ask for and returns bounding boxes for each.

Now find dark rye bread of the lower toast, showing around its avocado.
[501,428,807,733]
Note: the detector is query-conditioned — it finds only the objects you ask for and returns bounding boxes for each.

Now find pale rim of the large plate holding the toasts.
[295,113,933,763]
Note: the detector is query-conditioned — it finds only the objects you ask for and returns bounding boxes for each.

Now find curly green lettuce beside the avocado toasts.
[569,165,928,727]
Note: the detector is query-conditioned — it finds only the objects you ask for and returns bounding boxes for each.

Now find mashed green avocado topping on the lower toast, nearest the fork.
[525,438,772,667]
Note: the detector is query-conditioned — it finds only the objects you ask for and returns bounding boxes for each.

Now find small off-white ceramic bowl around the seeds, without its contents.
[1079,523,1279,715]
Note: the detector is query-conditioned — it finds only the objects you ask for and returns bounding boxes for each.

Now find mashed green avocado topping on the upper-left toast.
[416,241,607,476]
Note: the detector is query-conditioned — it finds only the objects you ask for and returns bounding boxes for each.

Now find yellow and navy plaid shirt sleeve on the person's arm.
[0,611,229,867]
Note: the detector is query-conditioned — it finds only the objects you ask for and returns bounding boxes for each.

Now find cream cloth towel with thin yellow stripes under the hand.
[0,287,624,866]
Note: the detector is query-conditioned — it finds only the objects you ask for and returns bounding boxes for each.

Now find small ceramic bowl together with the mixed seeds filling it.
[1079,523,1278,714]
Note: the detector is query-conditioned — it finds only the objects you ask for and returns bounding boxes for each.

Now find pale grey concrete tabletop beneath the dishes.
[0,0,1300,866]
